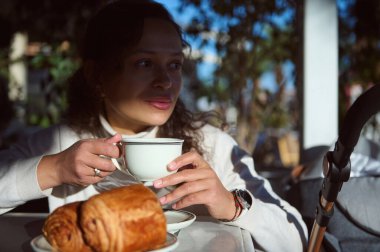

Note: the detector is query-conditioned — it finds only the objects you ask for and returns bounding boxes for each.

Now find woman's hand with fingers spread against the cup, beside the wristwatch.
[154,151,236,219]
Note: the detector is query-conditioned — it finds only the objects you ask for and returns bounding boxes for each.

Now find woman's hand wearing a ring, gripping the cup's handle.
[37,134,121,190]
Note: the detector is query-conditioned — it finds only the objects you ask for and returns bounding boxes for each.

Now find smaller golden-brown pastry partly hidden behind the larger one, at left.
[42,201,91,252]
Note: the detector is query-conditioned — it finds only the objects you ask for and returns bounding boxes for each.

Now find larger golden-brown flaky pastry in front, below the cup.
[80,185,166,252]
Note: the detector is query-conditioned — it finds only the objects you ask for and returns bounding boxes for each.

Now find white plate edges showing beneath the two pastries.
[30,233,178,252]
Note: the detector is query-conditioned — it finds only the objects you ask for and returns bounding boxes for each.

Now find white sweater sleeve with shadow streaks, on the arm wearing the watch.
[205,125,308,251]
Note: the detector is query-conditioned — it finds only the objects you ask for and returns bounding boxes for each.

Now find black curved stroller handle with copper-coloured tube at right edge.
[307,85,380,252]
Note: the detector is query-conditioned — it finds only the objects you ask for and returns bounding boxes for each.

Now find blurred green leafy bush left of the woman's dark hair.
[24,41,79,127]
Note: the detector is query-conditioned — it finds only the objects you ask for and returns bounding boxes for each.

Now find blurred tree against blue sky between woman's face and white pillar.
[179,0,297,153]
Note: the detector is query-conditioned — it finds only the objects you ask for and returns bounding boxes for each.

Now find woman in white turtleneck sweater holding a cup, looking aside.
[0,1,307,251]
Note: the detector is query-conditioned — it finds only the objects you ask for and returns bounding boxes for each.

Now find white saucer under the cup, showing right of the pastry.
[164,210,196,234]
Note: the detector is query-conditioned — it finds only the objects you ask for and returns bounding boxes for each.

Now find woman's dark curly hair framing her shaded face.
[66,0,221,154]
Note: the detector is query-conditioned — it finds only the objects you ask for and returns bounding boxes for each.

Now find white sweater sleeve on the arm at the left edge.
[0,126,60,214]
